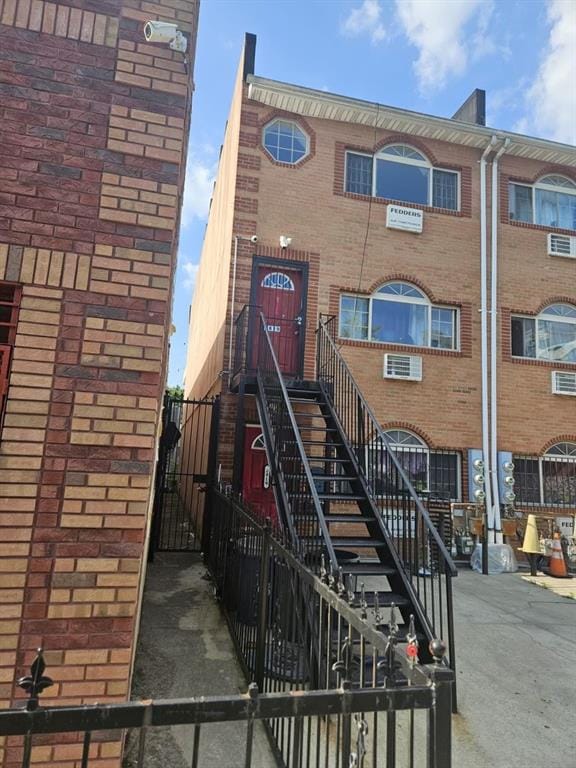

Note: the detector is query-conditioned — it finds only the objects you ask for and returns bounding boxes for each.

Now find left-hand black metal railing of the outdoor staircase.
[257,314,337,571]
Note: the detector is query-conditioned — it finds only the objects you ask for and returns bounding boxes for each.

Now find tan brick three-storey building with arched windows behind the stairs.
[185,35,576,541]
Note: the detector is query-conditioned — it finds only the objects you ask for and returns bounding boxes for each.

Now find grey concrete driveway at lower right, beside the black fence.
[454,571,576,768]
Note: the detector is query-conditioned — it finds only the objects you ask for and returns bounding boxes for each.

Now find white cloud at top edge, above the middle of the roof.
[396,0,496,91]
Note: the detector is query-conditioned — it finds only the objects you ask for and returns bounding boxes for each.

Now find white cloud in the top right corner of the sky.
[517,0,576,144]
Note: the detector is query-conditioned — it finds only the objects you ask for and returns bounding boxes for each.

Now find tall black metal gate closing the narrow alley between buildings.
[150,394,219,557]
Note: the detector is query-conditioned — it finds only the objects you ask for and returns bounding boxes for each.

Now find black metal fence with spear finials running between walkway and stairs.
[205,491,454,768]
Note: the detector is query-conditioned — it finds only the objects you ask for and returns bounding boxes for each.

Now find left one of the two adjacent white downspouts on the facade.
[480,136,497,538]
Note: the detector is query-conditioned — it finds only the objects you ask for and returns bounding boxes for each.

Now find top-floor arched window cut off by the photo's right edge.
[508,176,576,230]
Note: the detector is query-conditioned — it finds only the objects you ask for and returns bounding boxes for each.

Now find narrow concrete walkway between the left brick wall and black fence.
[124,554,276,768]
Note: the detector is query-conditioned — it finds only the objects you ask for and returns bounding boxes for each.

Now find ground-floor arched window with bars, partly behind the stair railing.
[366,429,460,501]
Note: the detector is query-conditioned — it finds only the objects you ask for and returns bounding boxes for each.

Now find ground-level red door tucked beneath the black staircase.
[242,427,278,525]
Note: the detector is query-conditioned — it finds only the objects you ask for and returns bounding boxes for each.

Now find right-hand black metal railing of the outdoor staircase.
[317,318,457,668]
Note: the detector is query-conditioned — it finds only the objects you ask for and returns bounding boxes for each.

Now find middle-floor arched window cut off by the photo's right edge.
[512,304,576,363]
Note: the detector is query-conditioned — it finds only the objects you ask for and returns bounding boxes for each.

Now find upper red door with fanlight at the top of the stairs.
[254,266,304,375]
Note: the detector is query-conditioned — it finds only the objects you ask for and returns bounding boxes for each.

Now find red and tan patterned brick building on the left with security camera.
[0,0,199,767]
